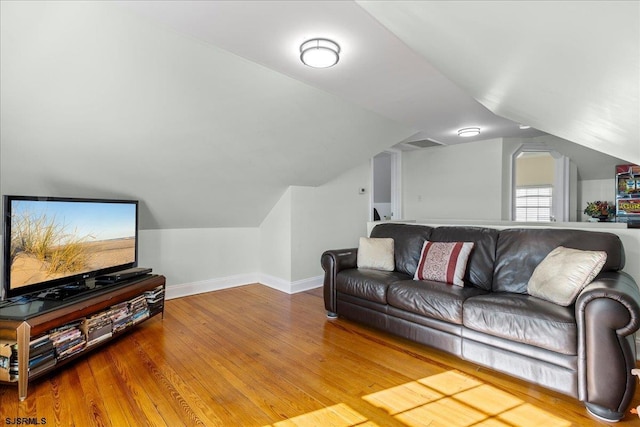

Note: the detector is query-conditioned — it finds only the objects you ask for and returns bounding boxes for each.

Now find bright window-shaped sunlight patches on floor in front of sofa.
[265,370,571,427]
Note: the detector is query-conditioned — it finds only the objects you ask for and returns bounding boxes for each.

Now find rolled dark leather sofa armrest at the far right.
[575,272,640,418]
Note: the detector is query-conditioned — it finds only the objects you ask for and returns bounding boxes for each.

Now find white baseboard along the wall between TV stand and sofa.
[166,273,323,299]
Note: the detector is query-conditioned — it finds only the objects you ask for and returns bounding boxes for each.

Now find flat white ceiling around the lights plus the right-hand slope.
[121,1,640,161]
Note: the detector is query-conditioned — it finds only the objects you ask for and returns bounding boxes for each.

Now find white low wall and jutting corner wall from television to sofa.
[0,161,371,298]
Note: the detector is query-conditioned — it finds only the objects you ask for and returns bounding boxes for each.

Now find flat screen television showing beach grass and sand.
[3,196,138,299]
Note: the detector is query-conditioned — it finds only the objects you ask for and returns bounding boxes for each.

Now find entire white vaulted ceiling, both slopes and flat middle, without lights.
[0,1,640,228]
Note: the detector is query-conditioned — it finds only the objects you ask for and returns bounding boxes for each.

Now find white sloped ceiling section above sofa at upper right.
[358,1,640,163]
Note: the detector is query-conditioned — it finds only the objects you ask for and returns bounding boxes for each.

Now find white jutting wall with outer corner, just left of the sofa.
[255,162,370,292]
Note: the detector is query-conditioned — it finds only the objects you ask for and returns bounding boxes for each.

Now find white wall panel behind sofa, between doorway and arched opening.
[402,139,503,220]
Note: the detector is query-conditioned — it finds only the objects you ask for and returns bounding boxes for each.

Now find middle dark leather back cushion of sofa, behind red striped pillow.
[429,227,499,290]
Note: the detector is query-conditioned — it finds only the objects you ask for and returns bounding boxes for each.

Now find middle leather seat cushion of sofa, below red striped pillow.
[387,280,486,325]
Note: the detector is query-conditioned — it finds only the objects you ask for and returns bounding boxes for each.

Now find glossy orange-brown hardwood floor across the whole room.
[0,285,640,427]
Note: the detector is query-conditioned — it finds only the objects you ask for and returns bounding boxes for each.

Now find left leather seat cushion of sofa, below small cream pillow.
[336,268,410,304]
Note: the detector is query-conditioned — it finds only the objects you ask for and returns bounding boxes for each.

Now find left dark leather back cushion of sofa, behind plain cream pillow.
[370,223,433,277]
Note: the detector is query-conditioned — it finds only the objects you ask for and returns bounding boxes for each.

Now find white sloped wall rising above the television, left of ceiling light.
[0,1,415,229]
